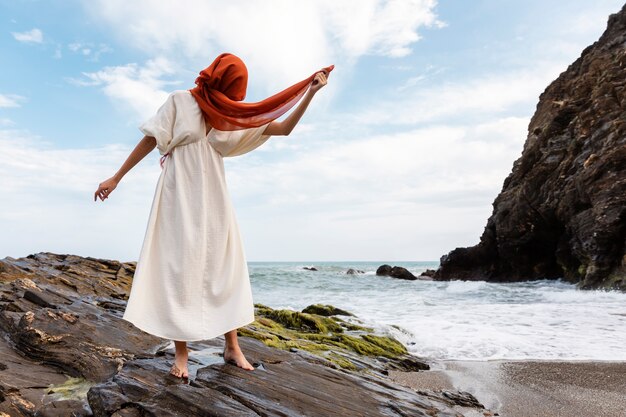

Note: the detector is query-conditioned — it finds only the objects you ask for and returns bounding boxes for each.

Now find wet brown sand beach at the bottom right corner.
[389,361,626,417]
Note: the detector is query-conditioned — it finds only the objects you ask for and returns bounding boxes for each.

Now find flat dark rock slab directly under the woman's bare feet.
[88,337,460,417]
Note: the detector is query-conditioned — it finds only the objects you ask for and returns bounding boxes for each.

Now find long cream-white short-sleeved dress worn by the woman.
[123,90,270,341]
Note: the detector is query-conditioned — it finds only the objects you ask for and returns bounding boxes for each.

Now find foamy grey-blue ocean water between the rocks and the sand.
[248,262,626,361]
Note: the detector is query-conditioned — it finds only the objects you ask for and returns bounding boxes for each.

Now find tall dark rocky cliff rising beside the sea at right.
[435,6,626,289]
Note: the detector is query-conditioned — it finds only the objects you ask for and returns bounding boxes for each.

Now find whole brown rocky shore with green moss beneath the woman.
[0,252,491,417]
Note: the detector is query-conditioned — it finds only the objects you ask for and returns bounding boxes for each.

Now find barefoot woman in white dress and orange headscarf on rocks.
[94,53,333,378]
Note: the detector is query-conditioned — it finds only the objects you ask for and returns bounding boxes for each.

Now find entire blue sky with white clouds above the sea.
[0,0,623,262]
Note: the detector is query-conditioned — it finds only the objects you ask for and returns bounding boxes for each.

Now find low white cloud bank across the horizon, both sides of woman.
[0,114,526,260]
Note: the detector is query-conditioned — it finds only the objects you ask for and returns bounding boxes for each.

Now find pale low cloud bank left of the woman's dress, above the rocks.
[0,129,160,260]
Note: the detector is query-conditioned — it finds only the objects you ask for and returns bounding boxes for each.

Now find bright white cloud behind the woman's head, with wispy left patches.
[68,0,441,123]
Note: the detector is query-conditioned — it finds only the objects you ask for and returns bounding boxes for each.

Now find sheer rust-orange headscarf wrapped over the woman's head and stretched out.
[189,53,335,130]
